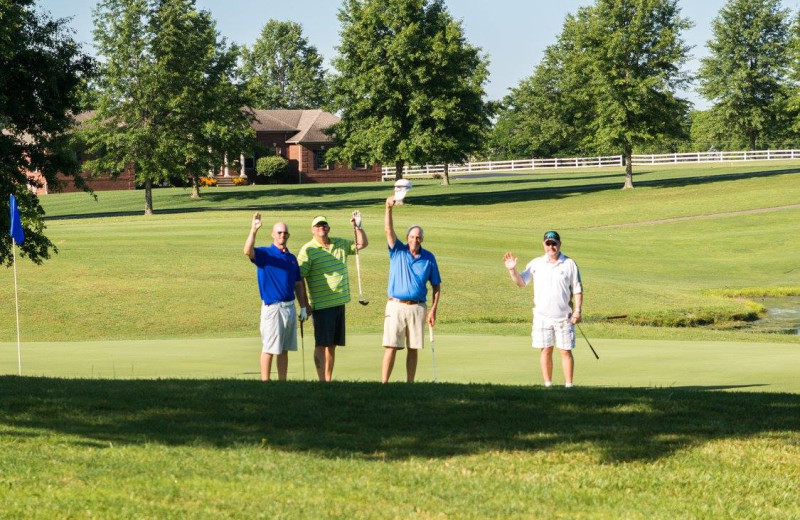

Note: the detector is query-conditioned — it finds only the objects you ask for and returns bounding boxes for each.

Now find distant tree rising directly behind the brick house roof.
[242,20,330,109]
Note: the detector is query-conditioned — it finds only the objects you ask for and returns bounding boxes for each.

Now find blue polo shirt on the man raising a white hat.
[387,240,442,302]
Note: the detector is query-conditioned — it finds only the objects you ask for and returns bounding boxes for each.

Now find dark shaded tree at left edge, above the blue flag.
[0,0,93,265]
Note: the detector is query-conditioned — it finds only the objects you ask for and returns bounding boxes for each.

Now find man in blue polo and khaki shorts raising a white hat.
[381,196,442,383]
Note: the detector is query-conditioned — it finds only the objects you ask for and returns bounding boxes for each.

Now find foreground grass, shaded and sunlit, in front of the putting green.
[0,377,800,519]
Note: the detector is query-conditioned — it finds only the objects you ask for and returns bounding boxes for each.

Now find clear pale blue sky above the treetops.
[37,0,800,108]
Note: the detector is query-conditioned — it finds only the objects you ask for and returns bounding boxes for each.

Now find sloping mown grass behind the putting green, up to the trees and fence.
[0,160,800,341]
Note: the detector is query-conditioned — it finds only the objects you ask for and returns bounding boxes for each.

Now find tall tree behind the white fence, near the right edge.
[699,0,790,150]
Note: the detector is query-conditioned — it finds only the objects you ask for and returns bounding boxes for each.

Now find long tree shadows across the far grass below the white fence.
[45,168,800,220]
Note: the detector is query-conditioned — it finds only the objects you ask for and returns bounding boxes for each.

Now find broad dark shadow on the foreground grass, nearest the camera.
[0,376,800,462]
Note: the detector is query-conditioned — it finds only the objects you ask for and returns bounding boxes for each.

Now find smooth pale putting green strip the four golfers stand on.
[0,334,800,393]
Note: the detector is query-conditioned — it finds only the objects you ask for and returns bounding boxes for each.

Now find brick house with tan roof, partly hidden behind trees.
[28,109,381,195]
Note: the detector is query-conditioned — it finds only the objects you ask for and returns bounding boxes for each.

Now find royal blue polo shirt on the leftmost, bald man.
[252,244,300,305]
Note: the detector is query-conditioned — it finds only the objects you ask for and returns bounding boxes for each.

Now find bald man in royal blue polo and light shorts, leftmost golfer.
[244,213,308,381]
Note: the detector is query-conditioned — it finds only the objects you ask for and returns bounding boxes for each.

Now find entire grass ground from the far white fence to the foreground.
[0,163,800,520]
